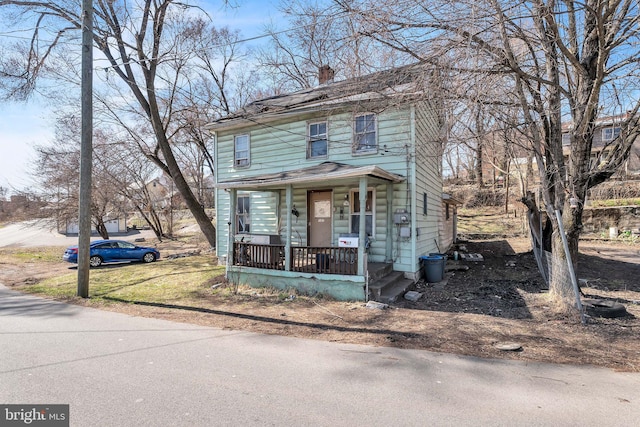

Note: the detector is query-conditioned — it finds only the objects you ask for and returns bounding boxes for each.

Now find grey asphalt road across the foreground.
[0,285,640,426]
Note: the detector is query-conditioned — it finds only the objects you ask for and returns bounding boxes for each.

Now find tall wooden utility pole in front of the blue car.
[78,0,93,298]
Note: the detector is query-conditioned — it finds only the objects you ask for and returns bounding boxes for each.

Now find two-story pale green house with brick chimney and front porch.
[207,65,451,300]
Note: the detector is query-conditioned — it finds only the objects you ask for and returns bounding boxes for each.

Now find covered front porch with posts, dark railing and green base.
[219,162,404,300]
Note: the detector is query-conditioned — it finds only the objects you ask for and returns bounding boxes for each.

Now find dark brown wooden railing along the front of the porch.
[233,242,358,276]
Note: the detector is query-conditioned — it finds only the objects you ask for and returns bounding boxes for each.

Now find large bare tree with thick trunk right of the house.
[334,0,640,308]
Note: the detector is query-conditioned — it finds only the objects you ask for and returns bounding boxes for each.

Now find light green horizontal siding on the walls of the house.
[216,98,446,290]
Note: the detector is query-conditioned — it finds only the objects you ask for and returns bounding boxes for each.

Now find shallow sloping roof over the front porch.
[216,162,405,188]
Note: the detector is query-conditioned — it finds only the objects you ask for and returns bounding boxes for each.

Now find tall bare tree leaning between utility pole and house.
[0,0,238,246]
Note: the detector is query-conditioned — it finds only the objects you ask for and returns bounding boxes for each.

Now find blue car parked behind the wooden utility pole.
[62,240,160,267]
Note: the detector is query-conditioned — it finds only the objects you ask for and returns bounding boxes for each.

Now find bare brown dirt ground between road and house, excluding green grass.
[0,238,640,372]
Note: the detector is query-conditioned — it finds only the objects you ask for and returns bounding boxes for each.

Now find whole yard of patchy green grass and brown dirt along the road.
[0,239,640,372]
